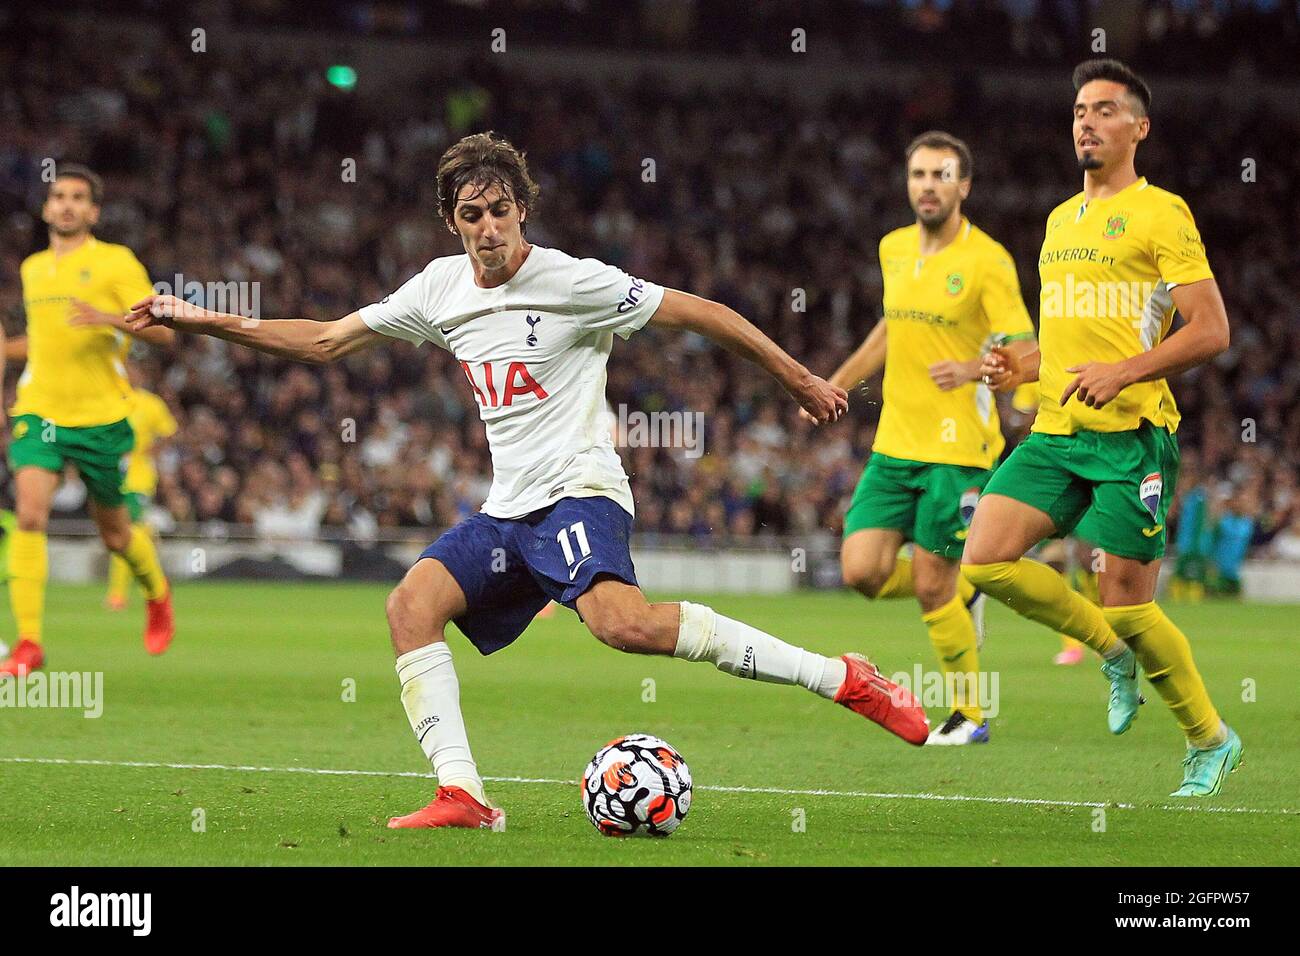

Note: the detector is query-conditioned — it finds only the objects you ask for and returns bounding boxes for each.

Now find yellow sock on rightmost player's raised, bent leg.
[962,558,1119,657]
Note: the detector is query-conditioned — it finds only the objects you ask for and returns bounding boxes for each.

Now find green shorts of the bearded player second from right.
[844,451,993,561]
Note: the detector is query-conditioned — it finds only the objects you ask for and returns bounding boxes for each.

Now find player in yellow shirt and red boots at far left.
[0,165,176,676]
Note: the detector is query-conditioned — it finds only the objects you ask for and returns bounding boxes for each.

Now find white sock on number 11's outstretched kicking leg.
[672,601,846,698]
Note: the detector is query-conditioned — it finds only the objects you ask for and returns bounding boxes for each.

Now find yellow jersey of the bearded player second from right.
[871,217,1034,468]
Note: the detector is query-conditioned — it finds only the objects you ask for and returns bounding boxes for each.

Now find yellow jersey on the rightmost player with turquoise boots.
[1034,178,1214,434]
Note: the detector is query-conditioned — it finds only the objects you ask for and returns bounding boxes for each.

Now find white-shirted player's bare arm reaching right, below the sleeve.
[650,289,849,423]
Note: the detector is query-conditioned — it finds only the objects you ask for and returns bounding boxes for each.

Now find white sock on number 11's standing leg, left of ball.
[398,641,488,804]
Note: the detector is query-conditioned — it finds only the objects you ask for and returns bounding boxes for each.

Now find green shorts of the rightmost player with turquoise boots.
[984,421,1179,561]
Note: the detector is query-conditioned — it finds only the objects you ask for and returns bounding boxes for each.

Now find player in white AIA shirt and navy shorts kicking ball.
[131,133,930,829]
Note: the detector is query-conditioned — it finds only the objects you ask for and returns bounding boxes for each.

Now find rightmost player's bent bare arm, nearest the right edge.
[1061,278,1229,408]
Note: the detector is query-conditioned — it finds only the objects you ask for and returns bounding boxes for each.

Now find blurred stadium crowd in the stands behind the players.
[0,13,1300,563]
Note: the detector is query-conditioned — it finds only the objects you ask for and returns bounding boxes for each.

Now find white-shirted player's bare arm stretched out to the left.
[127,295,384,365]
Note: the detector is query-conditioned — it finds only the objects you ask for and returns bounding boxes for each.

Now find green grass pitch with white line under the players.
[0,583,1300,866]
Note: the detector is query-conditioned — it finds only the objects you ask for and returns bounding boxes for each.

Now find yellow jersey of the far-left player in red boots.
[10,237,153,428]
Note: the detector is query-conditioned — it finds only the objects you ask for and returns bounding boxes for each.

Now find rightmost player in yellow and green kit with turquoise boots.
[963,60,1242,797]
